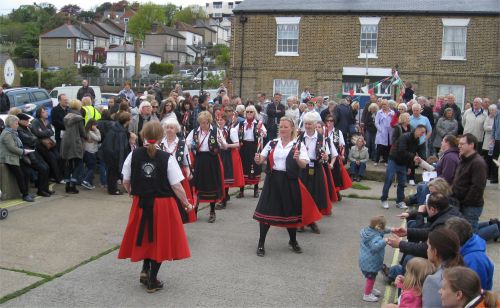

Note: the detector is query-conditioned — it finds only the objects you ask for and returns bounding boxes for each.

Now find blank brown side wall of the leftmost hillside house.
[41,38,76,67]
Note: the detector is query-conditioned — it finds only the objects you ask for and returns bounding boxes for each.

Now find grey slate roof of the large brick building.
[233,0,500,15]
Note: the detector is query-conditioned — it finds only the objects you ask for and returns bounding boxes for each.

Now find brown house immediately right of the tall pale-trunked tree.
[144,24,188,65]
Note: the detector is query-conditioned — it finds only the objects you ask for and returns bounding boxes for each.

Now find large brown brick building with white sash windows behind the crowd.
[231,0,500,105]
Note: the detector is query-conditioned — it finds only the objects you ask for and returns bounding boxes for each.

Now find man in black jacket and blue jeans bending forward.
[380,125,426,209]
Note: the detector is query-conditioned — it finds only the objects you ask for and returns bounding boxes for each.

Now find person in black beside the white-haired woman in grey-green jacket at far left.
[17,113,53,197]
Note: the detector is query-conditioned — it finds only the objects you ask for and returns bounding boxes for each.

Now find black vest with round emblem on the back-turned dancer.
[130,147,174,197]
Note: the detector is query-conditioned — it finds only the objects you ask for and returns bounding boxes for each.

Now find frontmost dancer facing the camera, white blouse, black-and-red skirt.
[253,117,322,257]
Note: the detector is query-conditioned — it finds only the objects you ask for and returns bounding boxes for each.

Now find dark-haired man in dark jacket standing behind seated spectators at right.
[452,134,488,232]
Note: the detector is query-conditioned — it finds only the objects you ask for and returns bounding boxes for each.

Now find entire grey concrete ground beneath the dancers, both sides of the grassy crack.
[0,181,500,307]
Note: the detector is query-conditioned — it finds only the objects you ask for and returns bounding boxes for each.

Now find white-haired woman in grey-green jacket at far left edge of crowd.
[0,115,34,202]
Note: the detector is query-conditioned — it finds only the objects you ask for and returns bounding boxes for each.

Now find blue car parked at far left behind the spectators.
[4,88,52,115]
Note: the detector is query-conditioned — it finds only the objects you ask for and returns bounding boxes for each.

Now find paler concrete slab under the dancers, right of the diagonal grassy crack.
[4,189,406,307]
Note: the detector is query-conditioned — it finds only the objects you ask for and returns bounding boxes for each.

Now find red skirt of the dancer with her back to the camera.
[118,196,191,262]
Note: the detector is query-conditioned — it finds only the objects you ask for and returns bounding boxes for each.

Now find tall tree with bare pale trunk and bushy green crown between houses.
[128,2,167,78]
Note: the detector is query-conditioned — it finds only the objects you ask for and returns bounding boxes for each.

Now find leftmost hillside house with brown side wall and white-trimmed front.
[40,24,94,68]
